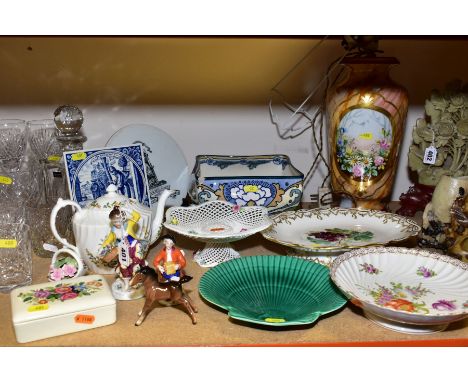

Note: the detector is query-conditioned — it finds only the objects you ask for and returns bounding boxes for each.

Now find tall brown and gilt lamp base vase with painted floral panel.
[327,57,408,210]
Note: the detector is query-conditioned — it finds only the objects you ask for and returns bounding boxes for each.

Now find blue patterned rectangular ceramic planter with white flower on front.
[190,154,304,213]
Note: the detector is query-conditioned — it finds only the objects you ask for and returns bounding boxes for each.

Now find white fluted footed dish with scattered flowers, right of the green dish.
[330,247,468,334]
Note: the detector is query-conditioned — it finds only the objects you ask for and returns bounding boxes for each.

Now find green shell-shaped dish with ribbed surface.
[199,255,346,326]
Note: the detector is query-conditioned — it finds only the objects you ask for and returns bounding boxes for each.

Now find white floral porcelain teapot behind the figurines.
[50,184,177,274]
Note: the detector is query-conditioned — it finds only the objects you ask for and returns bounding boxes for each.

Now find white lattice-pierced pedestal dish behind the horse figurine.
[164,200,271,267]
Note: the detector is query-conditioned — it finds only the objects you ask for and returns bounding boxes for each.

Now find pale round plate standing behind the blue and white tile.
[106,124,190,213]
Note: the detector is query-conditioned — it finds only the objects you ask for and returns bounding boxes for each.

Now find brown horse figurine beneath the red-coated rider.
[129,267,197,326]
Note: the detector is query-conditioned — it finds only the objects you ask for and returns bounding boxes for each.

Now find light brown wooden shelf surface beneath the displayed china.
[0,204,468,347]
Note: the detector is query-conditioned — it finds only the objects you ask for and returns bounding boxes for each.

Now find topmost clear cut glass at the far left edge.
[0,119,28,170]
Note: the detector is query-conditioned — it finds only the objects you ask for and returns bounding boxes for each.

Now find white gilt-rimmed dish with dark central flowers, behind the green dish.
[262,208,421,255]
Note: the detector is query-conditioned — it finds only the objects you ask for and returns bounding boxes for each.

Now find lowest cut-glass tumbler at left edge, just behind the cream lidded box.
[0,222,32,293]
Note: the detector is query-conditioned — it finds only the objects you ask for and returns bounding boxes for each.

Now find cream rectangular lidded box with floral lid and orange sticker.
[10,275,116,343]
